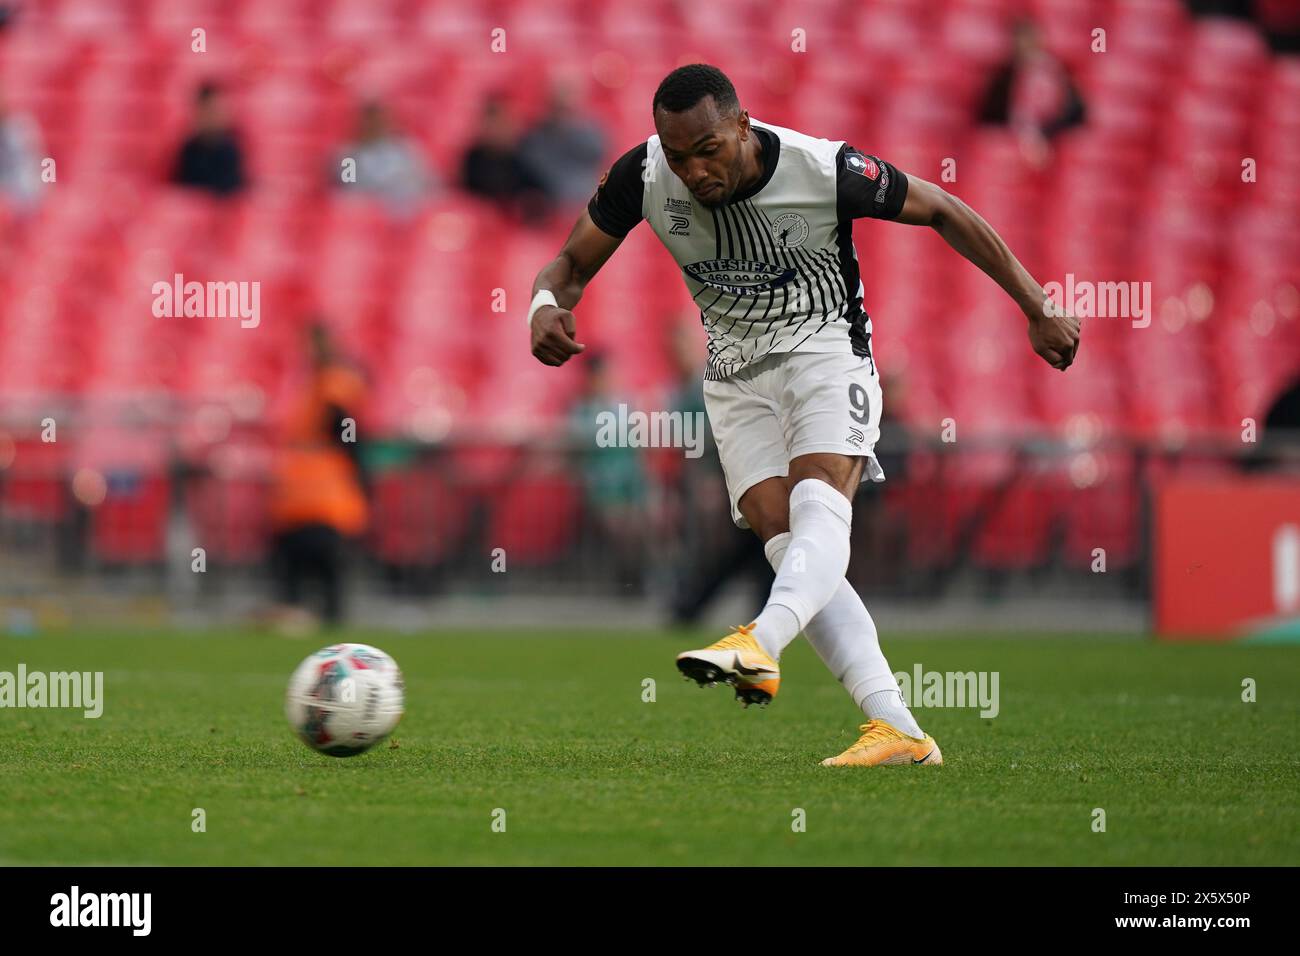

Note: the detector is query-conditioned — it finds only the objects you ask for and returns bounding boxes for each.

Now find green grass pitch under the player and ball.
[0,631,1300,865]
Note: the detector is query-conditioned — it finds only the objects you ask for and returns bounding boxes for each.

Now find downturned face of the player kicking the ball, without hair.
[654,96,750,206]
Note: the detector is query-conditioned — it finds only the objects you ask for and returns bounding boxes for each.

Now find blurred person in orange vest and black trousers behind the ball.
[269,324,369,630]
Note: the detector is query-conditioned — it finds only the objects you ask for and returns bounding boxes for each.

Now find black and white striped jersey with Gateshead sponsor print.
[588,118,907,380]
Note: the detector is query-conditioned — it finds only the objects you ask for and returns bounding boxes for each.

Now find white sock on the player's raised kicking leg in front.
[754,479,853,659]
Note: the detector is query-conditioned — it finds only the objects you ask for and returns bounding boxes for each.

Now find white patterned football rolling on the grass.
[285,644,406,757]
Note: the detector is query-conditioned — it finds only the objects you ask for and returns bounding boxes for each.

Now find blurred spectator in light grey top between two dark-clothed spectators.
[332,100,436,215]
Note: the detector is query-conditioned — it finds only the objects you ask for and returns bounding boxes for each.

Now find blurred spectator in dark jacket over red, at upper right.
[979,20,1084,165]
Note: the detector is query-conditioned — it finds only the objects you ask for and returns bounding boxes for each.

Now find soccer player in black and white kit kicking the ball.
[529,64,1079,766]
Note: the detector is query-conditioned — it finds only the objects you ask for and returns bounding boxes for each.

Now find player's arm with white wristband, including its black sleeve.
[529,143,646,365]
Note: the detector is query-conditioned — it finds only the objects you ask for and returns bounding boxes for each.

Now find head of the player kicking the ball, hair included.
[653,64,753,206]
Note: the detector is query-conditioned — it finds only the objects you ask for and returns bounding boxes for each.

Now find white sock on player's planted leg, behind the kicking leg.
[763,531,926,737]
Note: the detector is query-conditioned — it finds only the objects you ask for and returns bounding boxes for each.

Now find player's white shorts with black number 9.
[705,352,885,528]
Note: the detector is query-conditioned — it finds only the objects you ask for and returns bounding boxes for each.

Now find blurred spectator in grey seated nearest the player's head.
[519,82,605,207]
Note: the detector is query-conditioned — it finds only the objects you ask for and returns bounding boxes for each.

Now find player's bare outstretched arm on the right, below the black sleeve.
[896,173,1079,372]
